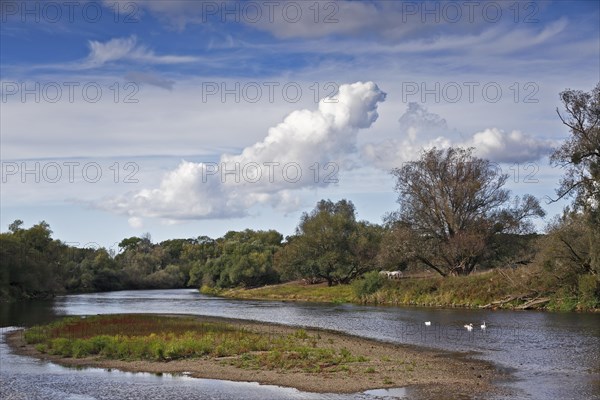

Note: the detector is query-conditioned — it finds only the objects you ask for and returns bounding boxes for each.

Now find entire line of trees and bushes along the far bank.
[0,83,600,299]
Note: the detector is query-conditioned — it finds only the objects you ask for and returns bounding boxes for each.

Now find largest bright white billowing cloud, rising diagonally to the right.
[97,82,386,223]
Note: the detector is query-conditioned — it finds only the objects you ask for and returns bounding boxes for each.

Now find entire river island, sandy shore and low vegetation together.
[8,314,500,398]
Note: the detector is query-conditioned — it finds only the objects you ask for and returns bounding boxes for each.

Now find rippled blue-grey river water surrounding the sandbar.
[0,289,600,400]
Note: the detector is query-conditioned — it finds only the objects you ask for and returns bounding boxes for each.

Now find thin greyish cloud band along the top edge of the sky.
[122,0,540,42]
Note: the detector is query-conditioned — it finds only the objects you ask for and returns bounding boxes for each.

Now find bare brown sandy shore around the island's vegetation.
[7,316,507,399]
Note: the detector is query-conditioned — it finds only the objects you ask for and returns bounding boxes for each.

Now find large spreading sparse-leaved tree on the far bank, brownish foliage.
[386,148,544,276]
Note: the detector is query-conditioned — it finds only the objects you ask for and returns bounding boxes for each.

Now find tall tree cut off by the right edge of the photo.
[550,83,600,274]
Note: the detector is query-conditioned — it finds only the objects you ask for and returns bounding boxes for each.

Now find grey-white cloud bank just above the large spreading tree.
[361,103,556,170]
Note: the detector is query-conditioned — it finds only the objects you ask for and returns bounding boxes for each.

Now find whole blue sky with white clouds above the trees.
[0,0,600,250]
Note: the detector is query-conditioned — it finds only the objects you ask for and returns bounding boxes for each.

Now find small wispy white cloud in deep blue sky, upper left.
[82,36,197,68]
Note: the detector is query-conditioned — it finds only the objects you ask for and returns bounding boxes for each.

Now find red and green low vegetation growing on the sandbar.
[24,315,368,372]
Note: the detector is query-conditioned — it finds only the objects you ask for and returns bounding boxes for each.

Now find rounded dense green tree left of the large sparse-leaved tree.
[277,200,381,286]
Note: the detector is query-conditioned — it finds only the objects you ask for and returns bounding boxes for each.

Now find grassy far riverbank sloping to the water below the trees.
[218,268,600,312]
